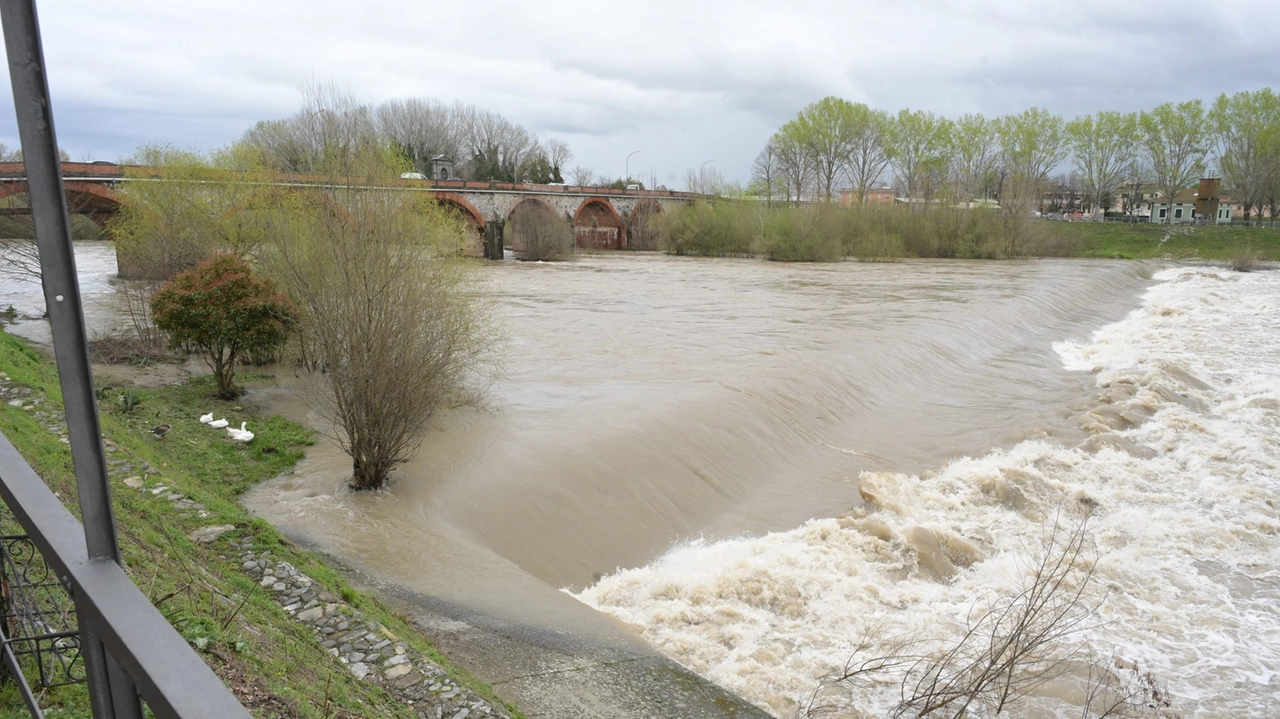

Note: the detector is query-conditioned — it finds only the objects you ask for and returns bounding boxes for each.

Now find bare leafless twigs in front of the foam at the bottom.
[801,509,1172,719]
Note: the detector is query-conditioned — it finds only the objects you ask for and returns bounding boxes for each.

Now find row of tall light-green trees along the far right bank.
[748,88,1280,219]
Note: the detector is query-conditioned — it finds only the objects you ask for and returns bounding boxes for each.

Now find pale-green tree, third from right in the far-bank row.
[1066,111,1138,212]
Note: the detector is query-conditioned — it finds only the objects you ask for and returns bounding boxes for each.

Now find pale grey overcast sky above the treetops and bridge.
[0,0,1280,188]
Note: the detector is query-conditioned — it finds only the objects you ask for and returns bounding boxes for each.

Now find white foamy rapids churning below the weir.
[577,269,1280,718]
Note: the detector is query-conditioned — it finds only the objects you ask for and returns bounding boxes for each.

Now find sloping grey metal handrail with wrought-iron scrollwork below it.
[0,434,248,719]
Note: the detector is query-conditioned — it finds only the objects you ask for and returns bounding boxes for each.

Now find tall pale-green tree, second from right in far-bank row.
[1138,100,1210,223]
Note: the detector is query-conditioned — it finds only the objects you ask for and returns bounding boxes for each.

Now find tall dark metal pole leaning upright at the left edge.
[0,0,142,719]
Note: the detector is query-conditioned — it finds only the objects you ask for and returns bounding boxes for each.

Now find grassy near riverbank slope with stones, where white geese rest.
[0,333,520,719]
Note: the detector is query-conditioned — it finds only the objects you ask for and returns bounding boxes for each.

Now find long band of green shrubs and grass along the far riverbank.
[648,201,1280,264]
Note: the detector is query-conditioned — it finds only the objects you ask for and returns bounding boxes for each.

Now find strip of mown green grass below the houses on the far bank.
[1046,221,1280,261]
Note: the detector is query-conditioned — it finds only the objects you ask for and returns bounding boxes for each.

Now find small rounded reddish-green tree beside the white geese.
[151,255,296,399]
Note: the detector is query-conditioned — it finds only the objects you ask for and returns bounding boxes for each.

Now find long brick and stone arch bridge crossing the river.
[0,162,708,260]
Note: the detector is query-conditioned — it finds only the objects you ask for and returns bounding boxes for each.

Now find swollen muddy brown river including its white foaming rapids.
[12,243,1280,718]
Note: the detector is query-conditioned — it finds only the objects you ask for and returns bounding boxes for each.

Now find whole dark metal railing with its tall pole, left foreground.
[0,0,248,719]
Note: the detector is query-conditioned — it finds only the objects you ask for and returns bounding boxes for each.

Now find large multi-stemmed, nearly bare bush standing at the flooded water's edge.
[265,188,494,490]
